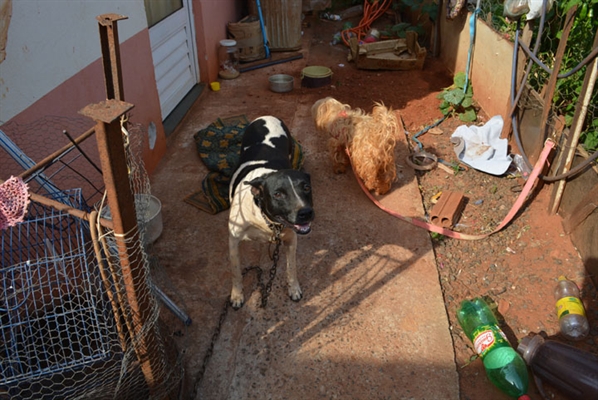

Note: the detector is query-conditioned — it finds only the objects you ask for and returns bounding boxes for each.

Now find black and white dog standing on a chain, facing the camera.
[228,116,314,309]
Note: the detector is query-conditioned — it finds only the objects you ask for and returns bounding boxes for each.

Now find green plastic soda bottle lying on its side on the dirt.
[457,297,529,400]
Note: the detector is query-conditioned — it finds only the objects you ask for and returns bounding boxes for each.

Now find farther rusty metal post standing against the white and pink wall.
[96,14,128,101]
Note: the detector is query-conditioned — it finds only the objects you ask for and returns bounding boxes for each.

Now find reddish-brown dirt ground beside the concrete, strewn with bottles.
[301,12,598,399]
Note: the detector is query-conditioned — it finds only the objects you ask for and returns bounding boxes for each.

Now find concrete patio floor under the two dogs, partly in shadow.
[151,15,459,400]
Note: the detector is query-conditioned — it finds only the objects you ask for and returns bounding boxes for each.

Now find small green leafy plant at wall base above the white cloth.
[437,72,477,122]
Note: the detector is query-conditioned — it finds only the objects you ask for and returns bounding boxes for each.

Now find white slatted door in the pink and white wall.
[145,0,199,120]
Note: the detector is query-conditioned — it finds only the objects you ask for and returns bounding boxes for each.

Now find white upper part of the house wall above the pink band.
[0,0,147,125]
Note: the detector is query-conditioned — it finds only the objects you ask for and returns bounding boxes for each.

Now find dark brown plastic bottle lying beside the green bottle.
[517,333,598,400]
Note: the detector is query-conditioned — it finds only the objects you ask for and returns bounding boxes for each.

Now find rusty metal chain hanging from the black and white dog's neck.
[191,225,282,400]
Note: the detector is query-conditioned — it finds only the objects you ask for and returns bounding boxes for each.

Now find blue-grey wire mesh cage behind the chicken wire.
[0,189,118,398]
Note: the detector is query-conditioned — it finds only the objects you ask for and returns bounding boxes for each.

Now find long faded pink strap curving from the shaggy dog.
[353,140,554,240]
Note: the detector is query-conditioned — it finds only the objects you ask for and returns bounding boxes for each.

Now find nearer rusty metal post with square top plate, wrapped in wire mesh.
[80,99,163,390]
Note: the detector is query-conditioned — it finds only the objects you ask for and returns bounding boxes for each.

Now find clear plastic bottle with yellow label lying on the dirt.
[554,275,590,340]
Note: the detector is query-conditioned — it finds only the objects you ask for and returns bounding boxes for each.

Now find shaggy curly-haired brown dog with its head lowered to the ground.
[311,97,400,195]
